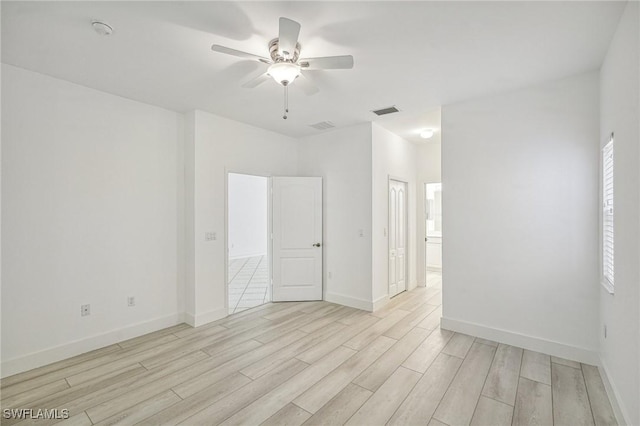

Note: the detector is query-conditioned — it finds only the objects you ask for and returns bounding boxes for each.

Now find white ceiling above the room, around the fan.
[2,1,624,136]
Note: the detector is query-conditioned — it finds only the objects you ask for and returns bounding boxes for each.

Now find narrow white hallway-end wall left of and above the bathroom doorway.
[416,142,442,286]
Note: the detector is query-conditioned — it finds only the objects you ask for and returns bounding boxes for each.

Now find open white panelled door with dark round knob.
[272,177,322,302]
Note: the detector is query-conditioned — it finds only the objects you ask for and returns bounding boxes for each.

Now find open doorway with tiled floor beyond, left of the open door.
[227,173,271,314]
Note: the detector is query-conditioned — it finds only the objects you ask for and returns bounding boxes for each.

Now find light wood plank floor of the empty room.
[1,276,615,426]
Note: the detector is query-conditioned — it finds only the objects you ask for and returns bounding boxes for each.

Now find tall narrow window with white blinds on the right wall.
[602,134,614,294]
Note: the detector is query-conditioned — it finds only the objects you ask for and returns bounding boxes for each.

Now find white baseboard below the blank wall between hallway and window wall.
[440,317,599,365]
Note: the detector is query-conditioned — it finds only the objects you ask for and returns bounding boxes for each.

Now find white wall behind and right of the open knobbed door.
[298,123,372,310]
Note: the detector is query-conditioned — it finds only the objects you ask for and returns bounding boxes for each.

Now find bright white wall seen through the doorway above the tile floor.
[227,173,268,259]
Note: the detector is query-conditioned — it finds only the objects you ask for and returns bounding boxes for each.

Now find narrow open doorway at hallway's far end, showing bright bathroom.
[424,183,442,287]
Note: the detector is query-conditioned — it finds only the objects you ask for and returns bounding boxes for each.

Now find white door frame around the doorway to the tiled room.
[224,167,273,317]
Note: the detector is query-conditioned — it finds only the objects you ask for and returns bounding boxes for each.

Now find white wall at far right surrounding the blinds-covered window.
[598,2,640,425]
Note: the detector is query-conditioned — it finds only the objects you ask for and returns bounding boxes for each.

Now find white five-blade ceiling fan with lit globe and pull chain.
[211,18,353,120]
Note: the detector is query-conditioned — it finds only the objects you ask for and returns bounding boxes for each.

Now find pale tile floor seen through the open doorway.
[229,256,271,314]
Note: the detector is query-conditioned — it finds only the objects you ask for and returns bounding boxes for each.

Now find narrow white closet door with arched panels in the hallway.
[389,180,407,297]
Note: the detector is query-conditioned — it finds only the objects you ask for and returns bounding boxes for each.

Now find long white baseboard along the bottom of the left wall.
[0,313,184,377]
